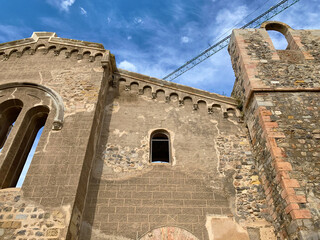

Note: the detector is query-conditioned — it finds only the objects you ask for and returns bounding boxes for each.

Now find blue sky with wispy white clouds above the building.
[0,0,320,95]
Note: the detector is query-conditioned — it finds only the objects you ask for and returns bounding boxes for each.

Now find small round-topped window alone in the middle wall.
[150,131,170,163]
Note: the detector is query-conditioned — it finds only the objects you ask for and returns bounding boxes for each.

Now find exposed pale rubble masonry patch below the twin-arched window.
[0,189,70,240]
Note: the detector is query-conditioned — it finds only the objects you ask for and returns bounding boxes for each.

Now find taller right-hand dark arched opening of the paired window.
[1,106,49,188]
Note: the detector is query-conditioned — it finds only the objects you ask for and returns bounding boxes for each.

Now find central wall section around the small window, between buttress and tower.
[81,72,272,239]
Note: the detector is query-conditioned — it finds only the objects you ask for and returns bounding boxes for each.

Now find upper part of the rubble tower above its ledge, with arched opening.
[228,21,320,106]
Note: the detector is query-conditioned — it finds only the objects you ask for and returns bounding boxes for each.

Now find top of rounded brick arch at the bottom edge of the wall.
[140,227,199,240]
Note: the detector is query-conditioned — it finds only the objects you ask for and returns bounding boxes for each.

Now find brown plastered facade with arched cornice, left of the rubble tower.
[0,30,284,240]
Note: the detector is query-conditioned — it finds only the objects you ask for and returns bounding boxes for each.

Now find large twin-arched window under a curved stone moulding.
[0,82,64,189]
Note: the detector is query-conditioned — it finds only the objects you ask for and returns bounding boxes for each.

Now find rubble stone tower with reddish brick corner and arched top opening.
[229,22,320,239]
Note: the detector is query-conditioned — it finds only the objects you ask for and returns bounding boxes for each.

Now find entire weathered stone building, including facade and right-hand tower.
[0,21,320,240]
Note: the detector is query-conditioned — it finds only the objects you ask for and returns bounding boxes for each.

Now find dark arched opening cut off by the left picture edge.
[0,99,23,151]
